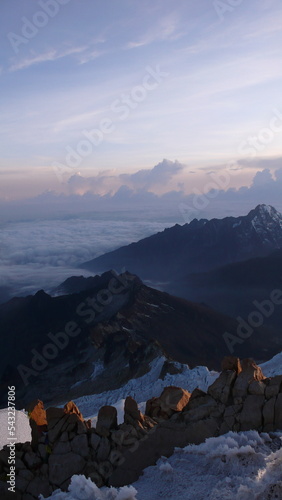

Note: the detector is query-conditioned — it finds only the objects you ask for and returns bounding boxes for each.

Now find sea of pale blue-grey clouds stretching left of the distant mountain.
[0,214,173,301]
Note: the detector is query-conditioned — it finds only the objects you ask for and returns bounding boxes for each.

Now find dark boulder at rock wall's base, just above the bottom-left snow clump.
[49,452,85,487]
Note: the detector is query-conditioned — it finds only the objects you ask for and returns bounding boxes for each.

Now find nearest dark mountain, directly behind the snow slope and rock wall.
[0,273,279,405]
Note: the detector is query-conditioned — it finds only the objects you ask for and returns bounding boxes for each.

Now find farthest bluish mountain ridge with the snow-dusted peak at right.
[81,205,282,281]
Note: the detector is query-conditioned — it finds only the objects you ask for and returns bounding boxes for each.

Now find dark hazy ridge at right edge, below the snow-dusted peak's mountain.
[169,250,282,326]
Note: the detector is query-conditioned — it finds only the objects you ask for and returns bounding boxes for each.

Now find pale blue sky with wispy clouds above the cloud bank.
[0,0,282,200]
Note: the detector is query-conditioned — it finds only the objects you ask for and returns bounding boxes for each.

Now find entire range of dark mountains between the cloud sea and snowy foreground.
[0,205,282,404]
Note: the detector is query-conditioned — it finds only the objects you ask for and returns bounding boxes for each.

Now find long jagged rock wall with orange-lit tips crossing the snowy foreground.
[0,358,282,500]
